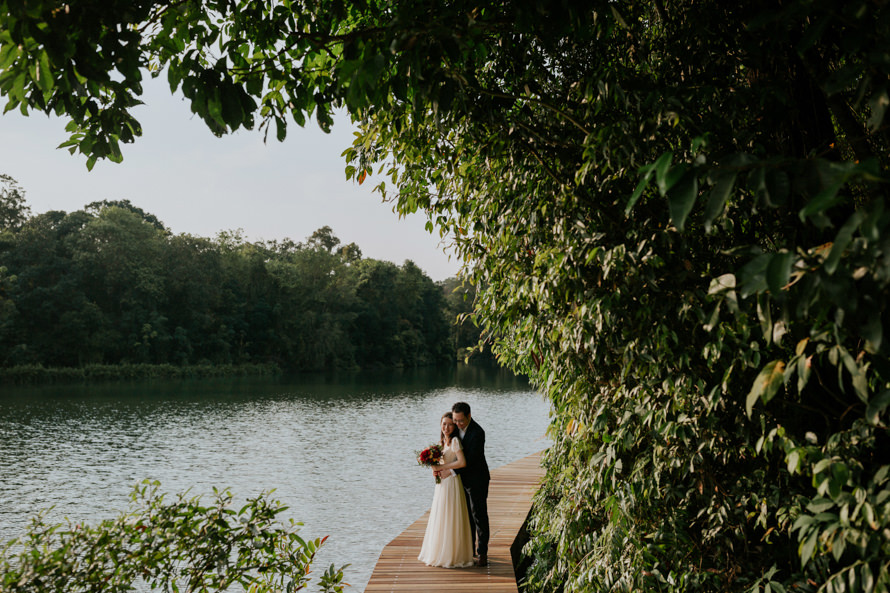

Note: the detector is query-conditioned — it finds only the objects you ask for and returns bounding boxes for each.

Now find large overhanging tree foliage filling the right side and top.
[0,0,890,591]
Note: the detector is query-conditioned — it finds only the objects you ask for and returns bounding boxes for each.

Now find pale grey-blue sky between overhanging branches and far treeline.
[0,75,460,280]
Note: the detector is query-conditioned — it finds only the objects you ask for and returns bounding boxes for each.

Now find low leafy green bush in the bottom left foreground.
[0,481,348,593]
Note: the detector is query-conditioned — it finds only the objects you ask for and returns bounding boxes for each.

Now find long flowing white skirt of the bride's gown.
[417,474,473,568]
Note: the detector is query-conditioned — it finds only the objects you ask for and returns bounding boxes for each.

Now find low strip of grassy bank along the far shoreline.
[0,364,281,385]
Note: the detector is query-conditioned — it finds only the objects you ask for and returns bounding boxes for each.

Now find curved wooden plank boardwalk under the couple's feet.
[365,453,544,593]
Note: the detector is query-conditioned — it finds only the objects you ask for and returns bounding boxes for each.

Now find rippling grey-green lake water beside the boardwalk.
[0,366,549,591]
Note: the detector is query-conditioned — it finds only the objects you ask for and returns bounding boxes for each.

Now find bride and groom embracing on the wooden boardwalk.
[417,402,490,568]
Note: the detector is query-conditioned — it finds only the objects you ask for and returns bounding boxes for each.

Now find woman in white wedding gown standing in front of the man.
[417,412,473,568]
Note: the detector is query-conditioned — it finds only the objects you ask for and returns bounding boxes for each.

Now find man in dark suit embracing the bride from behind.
[451,402,491,566]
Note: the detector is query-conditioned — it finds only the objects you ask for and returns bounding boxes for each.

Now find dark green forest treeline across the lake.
[0,177,486,371]
